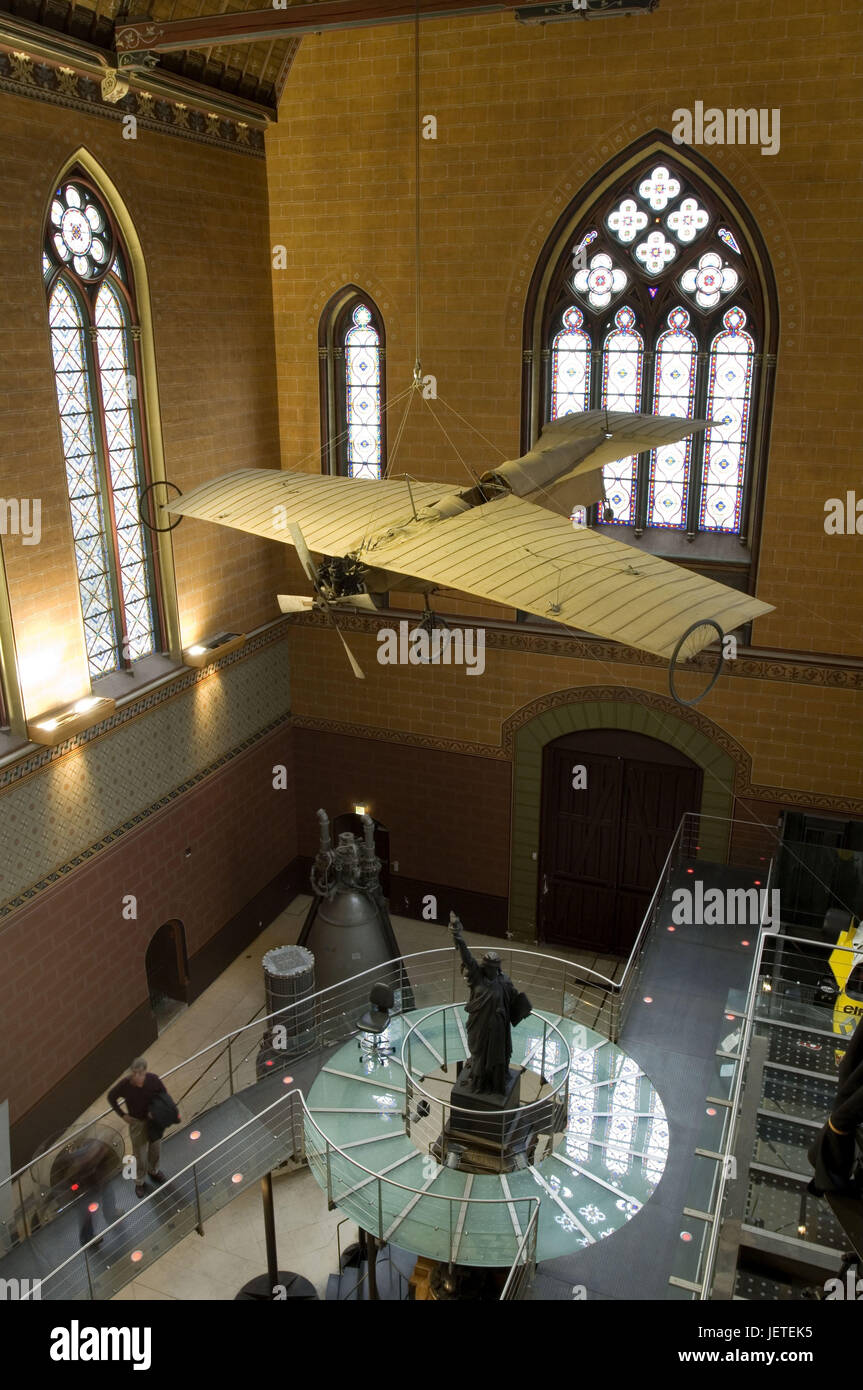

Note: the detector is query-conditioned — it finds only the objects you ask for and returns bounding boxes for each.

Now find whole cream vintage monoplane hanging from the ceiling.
[164,410,771,692]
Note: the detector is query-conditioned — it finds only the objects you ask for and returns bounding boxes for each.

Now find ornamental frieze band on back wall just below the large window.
[290,612,863,691]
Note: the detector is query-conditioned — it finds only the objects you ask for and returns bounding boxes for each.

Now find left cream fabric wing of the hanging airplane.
[164,468,457,555]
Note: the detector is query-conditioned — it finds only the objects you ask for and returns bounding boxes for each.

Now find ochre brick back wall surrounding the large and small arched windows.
[267,0,863,798]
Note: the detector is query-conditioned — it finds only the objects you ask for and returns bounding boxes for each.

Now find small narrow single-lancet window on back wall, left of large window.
[318,285,386,478]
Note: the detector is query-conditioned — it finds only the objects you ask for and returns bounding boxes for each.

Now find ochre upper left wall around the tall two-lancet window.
[0,93,282,714]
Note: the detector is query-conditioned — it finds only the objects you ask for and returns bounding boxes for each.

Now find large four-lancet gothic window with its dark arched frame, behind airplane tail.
[523,138,777,569]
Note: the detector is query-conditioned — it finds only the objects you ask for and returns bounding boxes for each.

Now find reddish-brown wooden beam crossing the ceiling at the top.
[115,0,524,54]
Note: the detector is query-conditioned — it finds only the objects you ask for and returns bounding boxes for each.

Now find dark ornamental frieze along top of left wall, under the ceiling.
[0,49,264,158]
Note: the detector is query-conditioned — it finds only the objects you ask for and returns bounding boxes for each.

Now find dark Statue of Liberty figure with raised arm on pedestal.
[449,912,531,1109]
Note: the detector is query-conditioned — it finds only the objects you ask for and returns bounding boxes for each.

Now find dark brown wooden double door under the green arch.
[536,728,702,955]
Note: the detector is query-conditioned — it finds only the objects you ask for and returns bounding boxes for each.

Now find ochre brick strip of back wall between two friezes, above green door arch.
[289,626,862,801]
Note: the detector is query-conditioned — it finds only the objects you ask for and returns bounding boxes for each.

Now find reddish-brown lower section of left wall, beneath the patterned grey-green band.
[0,726,296,1123]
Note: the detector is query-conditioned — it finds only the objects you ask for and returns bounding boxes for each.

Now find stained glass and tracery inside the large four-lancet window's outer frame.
[543,157,762,539]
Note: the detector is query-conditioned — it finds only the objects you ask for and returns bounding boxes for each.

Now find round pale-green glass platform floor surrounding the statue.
[306,1009,668,1266]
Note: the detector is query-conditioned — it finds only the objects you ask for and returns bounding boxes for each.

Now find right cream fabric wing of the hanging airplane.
[361,498,773,660]
